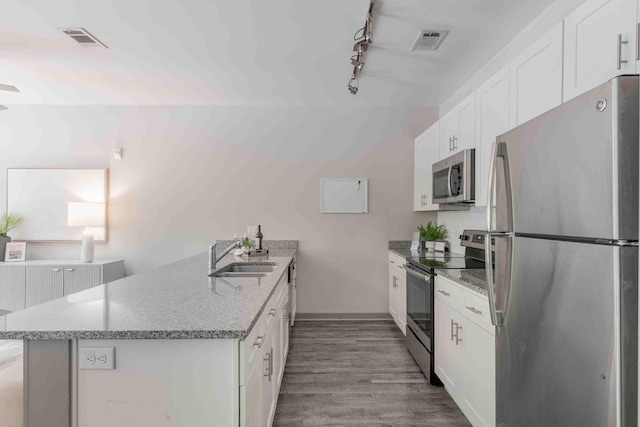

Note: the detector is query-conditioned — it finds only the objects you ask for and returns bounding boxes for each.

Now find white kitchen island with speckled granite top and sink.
[0,242,297,427]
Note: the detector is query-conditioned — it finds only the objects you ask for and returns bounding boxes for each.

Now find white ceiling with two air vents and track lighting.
[0,0,568,105]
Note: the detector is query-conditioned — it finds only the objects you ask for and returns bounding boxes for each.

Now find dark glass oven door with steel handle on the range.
[405,263,433,352]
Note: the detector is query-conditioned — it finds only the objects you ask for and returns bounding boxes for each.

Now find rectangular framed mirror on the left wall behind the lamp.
[7,168,109,242]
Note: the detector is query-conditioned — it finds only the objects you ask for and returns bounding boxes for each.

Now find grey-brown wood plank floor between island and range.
[274,320,470,427]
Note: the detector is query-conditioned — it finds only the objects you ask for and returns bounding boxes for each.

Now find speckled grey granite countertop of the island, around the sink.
[0,247,297,340]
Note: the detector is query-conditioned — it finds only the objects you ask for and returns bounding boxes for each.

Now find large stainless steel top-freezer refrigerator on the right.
[487,76,640,427]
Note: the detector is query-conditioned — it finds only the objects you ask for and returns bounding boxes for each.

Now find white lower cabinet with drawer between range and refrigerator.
[435,276,495,427]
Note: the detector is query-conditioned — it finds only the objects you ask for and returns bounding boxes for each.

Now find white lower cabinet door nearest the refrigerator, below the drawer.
[464,321,496,427]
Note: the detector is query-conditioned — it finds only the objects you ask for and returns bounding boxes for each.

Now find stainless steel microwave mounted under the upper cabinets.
[433,148,476,204]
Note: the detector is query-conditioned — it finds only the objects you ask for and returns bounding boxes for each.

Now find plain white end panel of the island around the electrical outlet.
[74,339,240,427]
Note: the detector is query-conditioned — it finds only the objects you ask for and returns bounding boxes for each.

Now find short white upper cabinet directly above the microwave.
[434,92,476,159]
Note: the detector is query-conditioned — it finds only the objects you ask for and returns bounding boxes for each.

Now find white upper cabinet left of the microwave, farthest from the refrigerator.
[413,122,440,212]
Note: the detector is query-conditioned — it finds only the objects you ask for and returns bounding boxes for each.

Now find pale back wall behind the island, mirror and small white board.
[0,106,437,313]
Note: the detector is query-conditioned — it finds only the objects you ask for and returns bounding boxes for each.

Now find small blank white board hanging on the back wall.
[320,178,369,214]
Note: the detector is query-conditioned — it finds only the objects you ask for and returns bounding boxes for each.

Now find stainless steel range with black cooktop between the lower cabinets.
[405,230,496,385]
